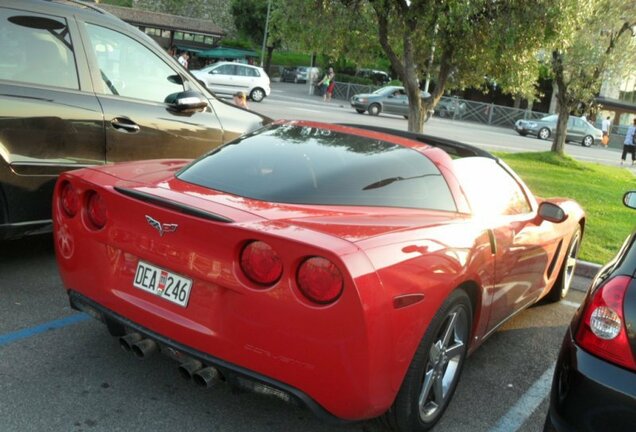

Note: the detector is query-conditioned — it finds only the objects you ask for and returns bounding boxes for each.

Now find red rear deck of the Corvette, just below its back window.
[91,160,459,242]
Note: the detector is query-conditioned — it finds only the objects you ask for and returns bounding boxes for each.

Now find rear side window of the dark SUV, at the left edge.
[0,9,79,89]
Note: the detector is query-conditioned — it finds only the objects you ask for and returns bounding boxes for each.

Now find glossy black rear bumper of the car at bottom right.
[546,330,636,432]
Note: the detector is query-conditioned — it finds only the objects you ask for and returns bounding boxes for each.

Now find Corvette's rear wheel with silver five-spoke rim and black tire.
[384,289,473,432]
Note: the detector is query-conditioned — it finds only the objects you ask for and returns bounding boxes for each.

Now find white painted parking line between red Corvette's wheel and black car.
[488,363,556,432]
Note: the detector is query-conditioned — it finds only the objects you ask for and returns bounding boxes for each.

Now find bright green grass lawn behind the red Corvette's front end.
[497,152,636,264]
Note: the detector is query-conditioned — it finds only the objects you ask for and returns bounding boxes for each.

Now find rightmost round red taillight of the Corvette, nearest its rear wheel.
[297,257,344,304]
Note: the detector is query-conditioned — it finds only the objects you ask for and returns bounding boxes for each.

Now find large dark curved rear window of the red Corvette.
[178,124,456,211]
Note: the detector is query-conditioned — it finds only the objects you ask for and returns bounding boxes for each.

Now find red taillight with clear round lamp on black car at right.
[575,276,636,370]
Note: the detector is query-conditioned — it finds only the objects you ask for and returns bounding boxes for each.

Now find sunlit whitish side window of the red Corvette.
[453,157,532,216]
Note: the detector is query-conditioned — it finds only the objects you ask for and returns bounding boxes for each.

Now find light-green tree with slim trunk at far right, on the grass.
[551,0,636,154]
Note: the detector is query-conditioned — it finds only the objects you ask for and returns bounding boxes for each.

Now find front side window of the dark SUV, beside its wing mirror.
[86,24,183,102]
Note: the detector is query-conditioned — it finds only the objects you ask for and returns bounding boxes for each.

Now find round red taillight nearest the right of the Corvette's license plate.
[241,241,283,285]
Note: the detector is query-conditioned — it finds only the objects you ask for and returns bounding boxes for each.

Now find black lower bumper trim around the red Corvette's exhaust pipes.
[68,291,349,424]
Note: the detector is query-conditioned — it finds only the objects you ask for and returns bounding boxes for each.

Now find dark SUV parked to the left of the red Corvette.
[0,0,268,240]
